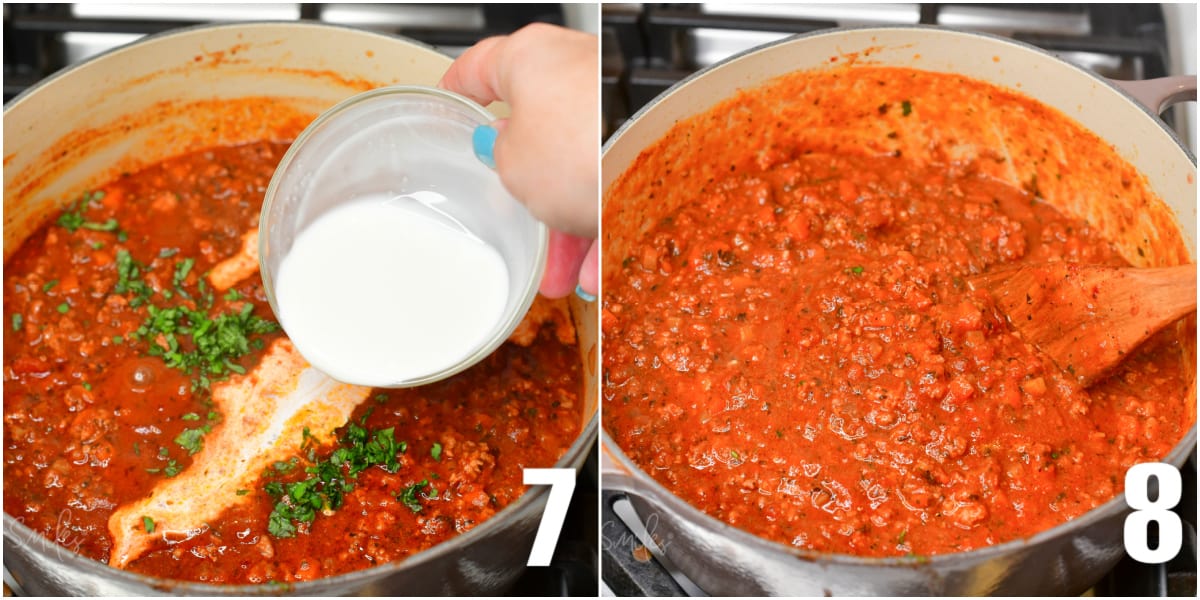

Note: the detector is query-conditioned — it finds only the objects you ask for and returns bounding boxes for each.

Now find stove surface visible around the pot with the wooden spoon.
[601,4,1196,598]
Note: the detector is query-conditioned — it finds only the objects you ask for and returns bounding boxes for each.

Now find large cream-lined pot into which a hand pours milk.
[4,23,598,596]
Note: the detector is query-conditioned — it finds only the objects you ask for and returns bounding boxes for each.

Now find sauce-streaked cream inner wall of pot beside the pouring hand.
[4,24,482,259]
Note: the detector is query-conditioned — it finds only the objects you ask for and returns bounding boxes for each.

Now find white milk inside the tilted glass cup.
[276,192,509,386]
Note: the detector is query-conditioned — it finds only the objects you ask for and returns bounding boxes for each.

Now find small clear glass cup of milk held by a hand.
[259,85,548,388]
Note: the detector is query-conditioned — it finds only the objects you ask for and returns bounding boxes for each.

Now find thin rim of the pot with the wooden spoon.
[600,25,1196,569]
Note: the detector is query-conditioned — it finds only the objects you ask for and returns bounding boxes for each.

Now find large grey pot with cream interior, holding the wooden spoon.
[601,28,1196,596]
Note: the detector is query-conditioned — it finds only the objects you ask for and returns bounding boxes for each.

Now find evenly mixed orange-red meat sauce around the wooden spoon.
[601,154,1190,556]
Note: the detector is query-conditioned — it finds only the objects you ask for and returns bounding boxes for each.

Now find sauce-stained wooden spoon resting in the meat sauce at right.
[967,263,1196,386]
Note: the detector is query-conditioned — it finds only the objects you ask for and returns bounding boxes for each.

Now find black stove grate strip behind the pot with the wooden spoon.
[601,4,1171,134]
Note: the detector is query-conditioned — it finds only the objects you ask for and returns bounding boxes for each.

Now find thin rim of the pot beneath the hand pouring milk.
[4,20,600,595]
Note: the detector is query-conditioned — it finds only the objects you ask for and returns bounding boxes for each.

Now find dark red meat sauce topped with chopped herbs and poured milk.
[4,142,582,583]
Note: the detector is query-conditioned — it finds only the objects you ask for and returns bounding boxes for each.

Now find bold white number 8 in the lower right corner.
[1124,462,1183,564]
